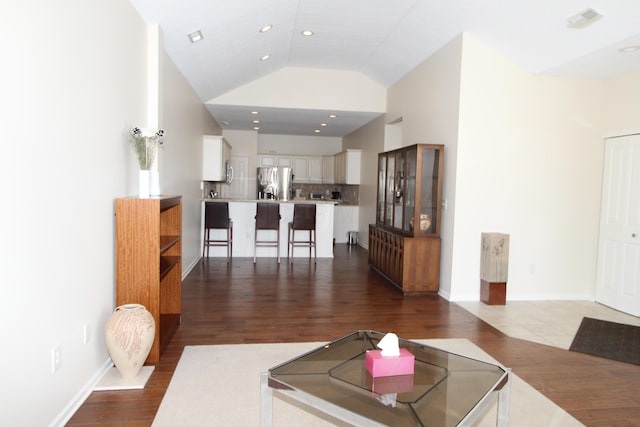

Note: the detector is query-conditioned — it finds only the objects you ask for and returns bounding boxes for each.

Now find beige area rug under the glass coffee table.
[153,339,582,427]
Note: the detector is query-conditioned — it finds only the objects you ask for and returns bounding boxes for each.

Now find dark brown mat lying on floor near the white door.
[569,317,640,365]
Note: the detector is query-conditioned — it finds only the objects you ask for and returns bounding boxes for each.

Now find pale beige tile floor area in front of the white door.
[456,301,640,350]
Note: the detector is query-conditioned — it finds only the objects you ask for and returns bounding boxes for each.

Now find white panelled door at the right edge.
[596,135,640,316]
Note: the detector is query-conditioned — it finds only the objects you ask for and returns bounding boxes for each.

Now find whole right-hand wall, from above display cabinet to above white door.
[380,34,620,300]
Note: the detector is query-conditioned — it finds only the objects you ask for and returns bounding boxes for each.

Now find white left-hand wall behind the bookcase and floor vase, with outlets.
[0,0,219,426]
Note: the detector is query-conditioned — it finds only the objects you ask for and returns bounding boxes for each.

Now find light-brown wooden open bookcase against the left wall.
[116,196,182,363]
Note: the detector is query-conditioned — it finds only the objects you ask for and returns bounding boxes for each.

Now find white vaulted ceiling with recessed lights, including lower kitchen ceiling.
[131,0,640,136]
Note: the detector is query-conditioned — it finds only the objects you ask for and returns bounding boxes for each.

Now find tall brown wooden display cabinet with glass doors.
[369,144,444,293]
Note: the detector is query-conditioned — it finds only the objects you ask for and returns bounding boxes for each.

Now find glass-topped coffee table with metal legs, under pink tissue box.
[261,330,509,427]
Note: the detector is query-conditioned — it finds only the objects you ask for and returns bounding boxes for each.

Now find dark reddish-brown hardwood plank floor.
[68,245,640,426]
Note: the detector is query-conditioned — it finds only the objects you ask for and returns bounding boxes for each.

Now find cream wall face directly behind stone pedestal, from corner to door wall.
[450,35,603,300]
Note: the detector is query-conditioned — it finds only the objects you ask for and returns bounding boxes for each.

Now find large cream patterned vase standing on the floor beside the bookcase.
[104,304,156,379]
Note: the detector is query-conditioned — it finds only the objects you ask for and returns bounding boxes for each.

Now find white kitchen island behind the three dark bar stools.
[200,198,335,258]
